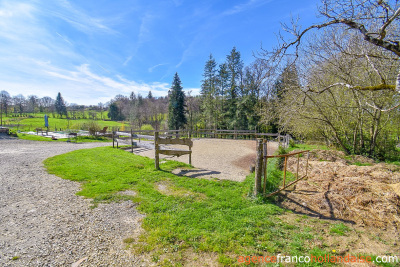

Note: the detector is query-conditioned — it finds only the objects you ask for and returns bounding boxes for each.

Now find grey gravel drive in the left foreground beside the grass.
[0,136,148,266]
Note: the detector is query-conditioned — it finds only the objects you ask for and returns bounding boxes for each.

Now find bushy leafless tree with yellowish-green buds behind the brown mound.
[275,28,400,158]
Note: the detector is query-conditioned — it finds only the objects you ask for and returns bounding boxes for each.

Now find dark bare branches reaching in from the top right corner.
[261,0,400,98]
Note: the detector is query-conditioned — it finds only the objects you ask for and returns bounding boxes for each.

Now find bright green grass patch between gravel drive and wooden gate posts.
[45,148,394,266]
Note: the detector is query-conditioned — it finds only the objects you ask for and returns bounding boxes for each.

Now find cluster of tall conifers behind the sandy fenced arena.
[201,47,268,132]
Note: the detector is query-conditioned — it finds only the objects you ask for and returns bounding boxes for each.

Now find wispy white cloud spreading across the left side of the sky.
[0,0,169,104]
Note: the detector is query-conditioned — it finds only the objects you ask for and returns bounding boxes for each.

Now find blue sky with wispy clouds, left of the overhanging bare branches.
[0,0,318,104]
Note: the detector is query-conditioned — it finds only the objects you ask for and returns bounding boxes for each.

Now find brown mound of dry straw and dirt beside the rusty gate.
[283,150,400,229]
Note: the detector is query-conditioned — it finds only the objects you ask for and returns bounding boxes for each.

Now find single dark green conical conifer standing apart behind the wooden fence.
[168,73,187,130]
